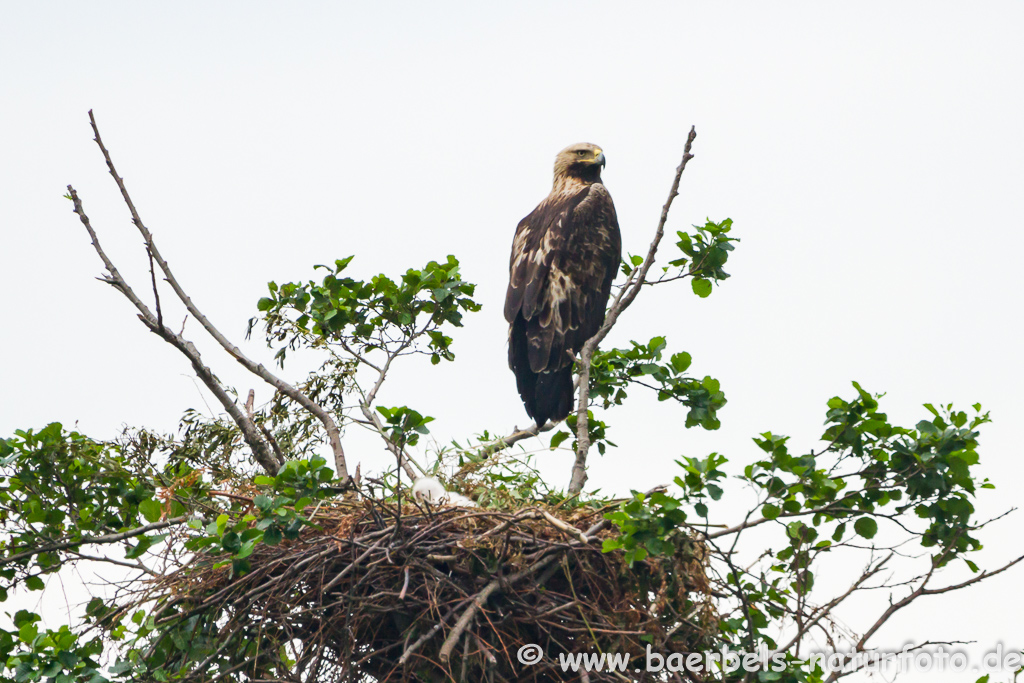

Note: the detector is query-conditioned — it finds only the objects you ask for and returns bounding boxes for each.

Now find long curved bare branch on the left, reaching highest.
[89,110,348,478]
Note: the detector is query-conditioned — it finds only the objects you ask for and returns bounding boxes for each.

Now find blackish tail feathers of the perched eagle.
[509,315,573,427]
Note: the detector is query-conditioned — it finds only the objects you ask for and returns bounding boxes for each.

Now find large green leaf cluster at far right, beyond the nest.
[744,383,991,565]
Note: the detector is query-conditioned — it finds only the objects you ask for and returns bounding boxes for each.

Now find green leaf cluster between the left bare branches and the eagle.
[249,256,480,364]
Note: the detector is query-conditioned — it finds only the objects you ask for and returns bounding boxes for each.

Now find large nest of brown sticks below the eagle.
[149,501,717,682]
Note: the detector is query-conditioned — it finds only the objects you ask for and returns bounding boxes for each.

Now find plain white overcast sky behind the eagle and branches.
[0,2,1024,681]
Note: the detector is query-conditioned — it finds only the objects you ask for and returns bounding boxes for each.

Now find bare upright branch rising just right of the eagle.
[568,126,697,496]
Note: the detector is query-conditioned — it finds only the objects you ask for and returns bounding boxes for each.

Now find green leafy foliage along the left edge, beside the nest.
[0,416,348,683]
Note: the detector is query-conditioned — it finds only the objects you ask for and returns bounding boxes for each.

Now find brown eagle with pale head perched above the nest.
[505,142,622,426]
